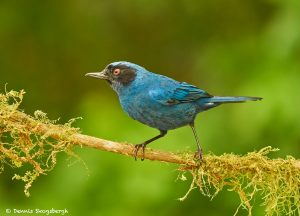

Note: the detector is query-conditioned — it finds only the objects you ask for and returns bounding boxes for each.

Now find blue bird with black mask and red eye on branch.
[86,61,262,161]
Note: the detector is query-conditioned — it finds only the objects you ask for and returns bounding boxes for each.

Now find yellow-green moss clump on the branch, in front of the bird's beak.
[0,90,78,196]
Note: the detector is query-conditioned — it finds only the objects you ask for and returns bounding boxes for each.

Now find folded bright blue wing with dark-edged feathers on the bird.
[149,82,212,105]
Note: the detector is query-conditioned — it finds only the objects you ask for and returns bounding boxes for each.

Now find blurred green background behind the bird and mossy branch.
[0,0,300,216]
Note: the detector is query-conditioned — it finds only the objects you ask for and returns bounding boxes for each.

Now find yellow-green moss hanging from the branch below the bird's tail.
[180,147,300,215]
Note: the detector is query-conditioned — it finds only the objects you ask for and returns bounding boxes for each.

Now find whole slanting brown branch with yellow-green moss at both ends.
[0,88,300,215]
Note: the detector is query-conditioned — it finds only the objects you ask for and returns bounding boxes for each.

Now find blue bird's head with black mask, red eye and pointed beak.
[86,61,145,89]
